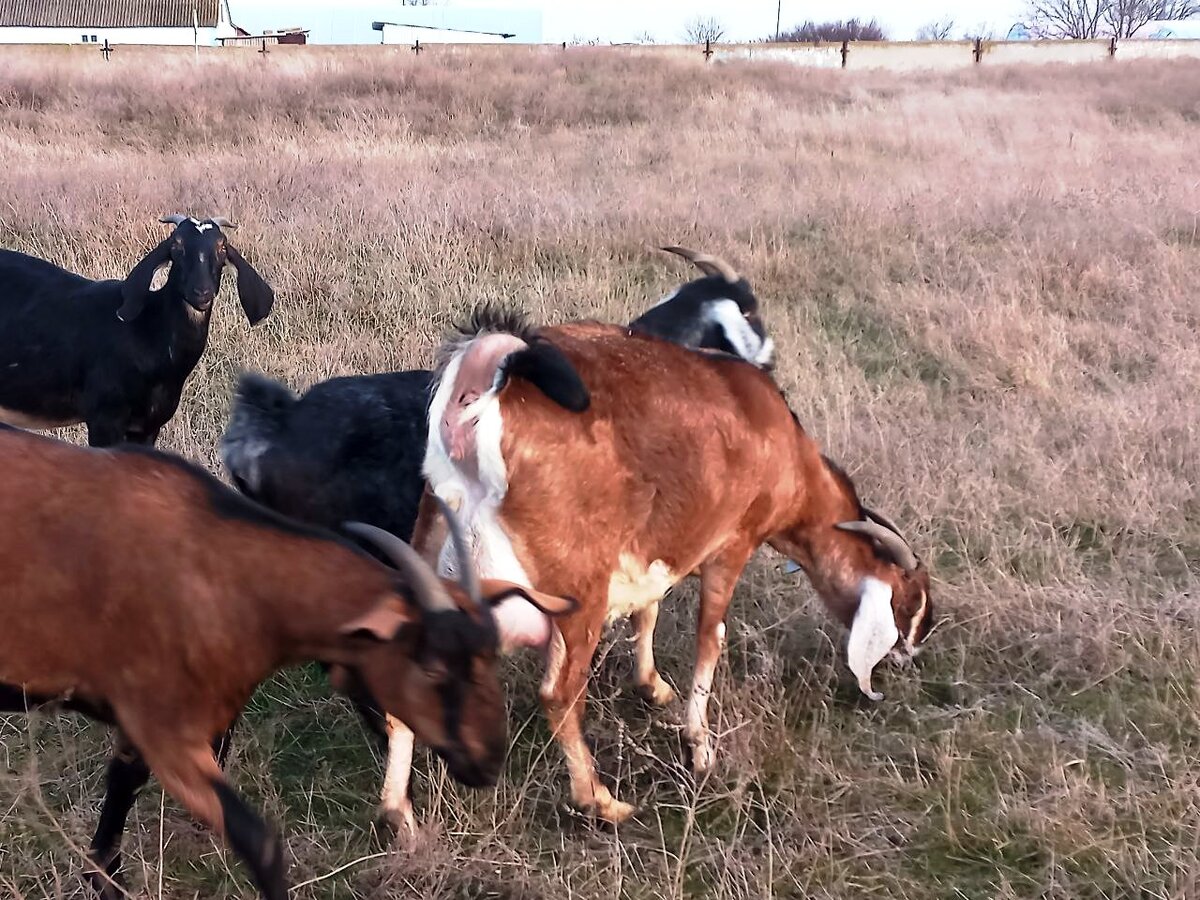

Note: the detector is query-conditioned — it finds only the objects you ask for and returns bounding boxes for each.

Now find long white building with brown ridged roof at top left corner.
[0,0,238,47]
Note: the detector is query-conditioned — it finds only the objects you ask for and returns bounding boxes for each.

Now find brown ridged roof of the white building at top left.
[0,0,220,28]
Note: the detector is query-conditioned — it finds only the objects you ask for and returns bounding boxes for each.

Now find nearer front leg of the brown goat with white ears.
[686,547,754,773]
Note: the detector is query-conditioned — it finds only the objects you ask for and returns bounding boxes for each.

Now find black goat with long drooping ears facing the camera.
[0,216,275,446]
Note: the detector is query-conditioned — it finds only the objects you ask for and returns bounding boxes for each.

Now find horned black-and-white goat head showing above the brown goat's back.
[629,247,775,368]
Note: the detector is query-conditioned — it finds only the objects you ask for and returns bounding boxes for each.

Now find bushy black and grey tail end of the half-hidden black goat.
[220,372,298,497]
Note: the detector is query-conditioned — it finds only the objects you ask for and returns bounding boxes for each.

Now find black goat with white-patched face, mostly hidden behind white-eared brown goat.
[221,247,772,549]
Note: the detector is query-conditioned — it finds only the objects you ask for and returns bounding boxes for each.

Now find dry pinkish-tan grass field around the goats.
[0,48,1200,900]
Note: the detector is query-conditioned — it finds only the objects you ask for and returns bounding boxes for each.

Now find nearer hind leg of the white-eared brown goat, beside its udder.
[541,600,634,822]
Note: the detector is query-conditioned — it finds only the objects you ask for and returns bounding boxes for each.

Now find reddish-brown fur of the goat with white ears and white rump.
[427,323,932,820]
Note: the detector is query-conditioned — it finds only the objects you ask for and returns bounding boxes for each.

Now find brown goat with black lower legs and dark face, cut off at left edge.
[0,426,570,900]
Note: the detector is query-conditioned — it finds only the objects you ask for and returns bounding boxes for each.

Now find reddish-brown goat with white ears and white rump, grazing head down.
[414,312,934,821]
